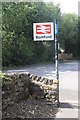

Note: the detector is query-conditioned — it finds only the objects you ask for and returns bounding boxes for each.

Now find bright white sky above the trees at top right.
[45,0,80,15]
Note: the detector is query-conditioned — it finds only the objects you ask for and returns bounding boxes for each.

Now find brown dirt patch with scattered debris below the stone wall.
[2,99,57,120]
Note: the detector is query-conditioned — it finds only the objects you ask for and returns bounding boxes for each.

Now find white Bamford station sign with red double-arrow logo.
[33,22,54,41]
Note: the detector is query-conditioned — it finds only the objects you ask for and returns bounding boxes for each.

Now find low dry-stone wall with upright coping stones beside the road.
[2,73,59,110]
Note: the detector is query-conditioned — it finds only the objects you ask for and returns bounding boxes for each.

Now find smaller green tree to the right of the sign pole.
[59,14,78,56]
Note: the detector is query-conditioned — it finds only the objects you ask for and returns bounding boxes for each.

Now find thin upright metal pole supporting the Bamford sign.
[55,19,59,80]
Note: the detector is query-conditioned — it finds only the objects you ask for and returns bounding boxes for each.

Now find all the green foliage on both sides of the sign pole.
[2,2,78,66]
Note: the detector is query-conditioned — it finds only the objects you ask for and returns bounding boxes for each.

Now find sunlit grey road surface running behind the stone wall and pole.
[4,60,78,117]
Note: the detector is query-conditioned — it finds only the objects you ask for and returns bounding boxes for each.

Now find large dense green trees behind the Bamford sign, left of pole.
[2,2,61,66]
